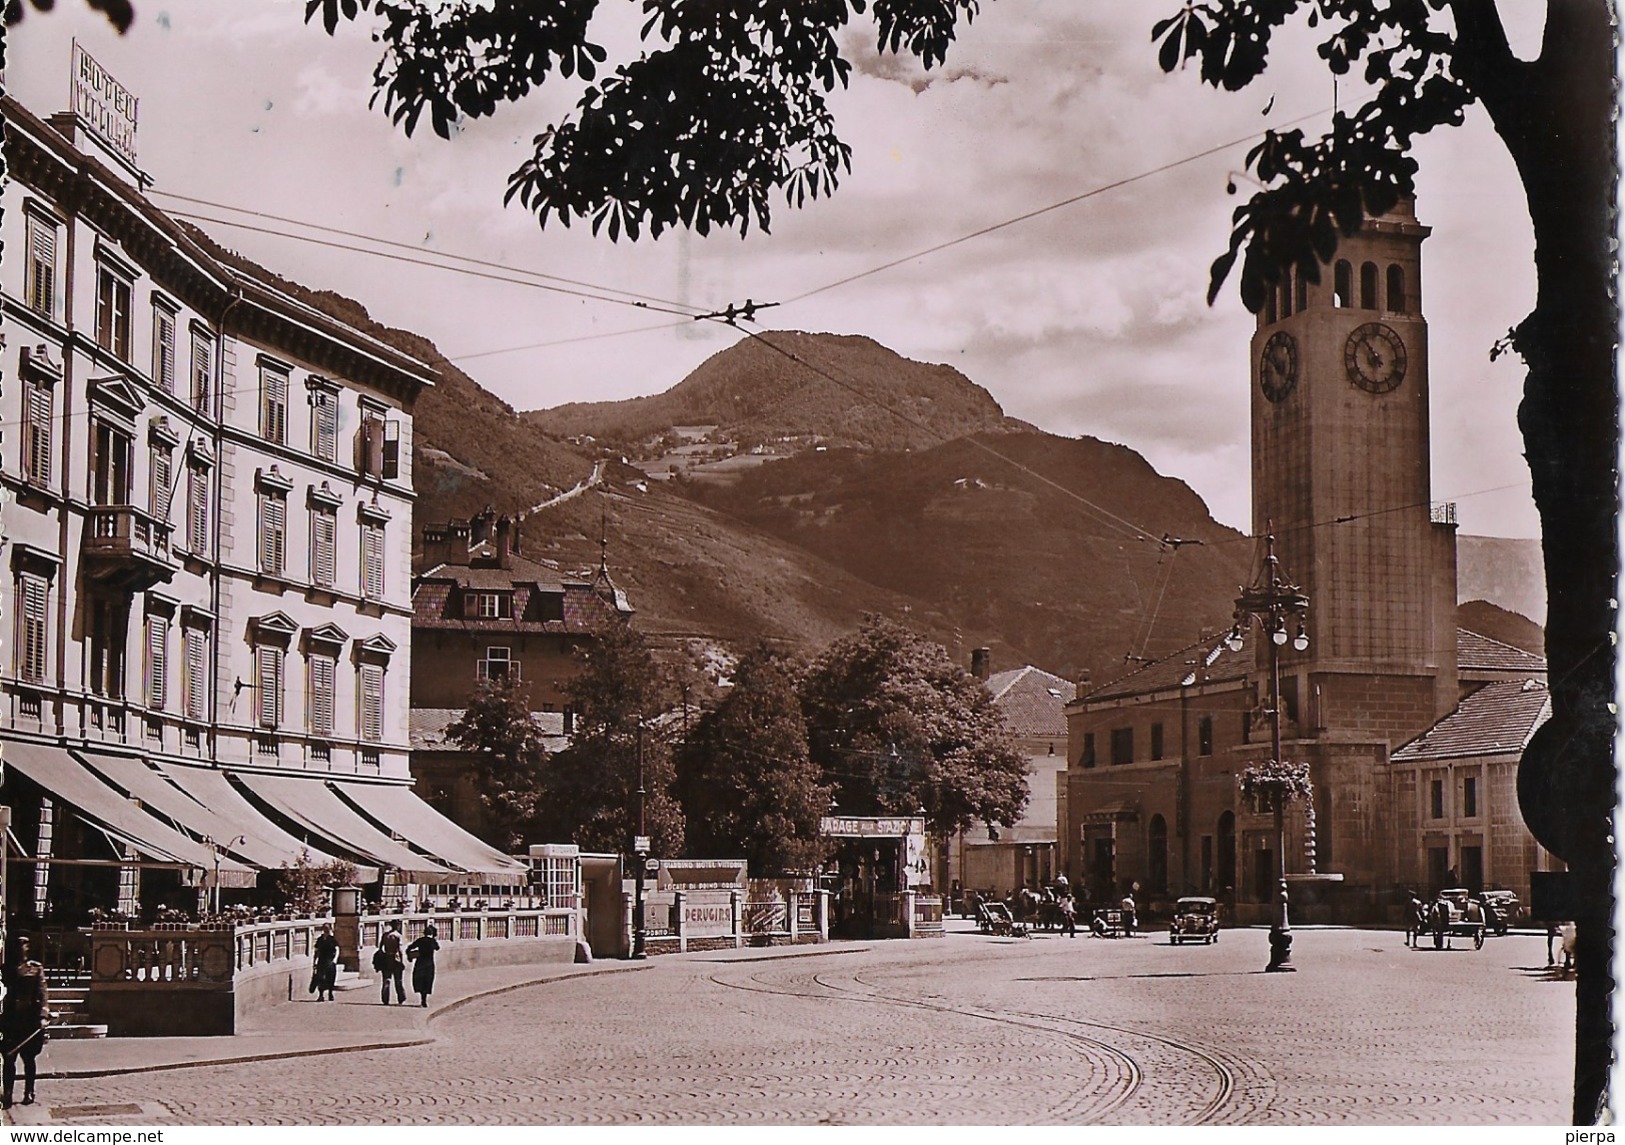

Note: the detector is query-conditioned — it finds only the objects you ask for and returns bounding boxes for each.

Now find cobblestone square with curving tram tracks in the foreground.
[28,931,1575,1126]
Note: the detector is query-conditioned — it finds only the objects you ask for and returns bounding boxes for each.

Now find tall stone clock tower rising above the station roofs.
[1251,200,1458,782]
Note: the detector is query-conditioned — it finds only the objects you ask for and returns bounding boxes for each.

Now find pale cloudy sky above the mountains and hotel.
[7,0,1544,538]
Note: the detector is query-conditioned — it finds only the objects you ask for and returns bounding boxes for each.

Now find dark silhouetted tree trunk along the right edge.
[1480,0,1619,1124]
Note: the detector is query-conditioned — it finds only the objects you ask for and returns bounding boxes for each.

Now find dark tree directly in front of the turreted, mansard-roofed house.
[540,620,683,856]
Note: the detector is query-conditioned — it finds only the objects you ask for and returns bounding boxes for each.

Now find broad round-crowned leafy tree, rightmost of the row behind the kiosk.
[801,616,1027,836]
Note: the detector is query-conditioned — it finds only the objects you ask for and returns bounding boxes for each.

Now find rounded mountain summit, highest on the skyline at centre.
[525,330,1021,450]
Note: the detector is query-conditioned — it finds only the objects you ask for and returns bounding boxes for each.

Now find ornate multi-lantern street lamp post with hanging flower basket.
[1225,525,1310,971]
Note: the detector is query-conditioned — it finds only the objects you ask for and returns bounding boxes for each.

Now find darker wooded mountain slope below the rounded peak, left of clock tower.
[674,432,1253,681]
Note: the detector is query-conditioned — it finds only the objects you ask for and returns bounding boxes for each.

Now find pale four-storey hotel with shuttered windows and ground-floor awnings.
[0,77,520,921]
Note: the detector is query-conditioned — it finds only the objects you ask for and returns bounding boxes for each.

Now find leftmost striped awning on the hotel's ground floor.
[0,739,254,887]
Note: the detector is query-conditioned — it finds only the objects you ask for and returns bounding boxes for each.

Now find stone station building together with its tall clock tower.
[1061,203,1549,919]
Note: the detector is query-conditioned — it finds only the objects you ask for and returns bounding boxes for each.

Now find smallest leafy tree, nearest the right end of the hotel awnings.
[445,679,548,851]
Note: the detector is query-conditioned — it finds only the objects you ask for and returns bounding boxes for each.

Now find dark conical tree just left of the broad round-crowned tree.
[676,645,830,874]
